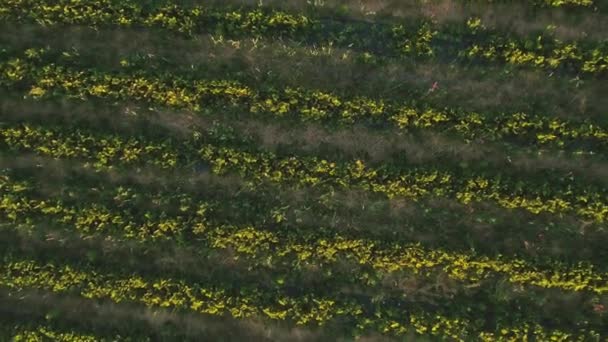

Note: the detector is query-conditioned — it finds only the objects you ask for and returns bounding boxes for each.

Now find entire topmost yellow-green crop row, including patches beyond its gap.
[0,0,608,74]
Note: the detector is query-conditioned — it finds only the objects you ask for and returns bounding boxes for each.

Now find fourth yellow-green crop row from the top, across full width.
[0,172,608,293]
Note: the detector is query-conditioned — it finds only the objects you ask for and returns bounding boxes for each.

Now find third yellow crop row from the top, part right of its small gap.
[200,145,608,222]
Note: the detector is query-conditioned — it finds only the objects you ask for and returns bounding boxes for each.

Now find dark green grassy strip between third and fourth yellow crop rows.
[1,160,608,270]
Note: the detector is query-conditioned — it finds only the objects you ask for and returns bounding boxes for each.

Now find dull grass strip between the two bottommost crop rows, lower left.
[0,291,306,341]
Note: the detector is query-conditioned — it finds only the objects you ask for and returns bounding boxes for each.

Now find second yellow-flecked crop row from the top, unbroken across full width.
[0,54,608,154]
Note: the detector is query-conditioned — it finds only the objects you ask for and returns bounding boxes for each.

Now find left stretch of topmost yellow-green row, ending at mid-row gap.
[0,0,311,34]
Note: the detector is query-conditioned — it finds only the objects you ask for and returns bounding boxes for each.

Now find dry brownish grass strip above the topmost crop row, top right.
[198,0,608,40]
